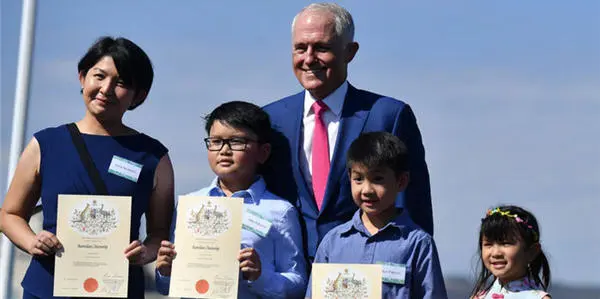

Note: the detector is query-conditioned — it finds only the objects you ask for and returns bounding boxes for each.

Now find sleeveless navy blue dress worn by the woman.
[21,125,168,298]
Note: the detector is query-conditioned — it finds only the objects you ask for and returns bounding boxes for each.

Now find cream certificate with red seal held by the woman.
[54,195,131,298]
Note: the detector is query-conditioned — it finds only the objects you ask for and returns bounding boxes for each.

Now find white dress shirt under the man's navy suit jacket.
[300,81,348,188]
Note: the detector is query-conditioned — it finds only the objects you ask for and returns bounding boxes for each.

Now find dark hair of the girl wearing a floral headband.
[471,205,550,296]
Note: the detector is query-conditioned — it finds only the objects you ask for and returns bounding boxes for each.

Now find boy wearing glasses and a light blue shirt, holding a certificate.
[156,102,307,298]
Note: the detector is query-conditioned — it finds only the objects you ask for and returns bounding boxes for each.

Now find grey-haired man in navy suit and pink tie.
[263,3,433,261]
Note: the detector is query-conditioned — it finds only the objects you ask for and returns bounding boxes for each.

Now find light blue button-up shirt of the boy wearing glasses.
[156,177,307,298]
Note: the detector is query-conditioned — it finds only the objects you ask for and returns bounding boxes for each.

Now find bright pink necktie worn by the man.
[312,101,329,210]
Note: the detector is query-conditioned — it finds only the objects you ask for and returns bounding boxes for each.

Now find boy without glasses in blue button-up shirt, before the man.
[306,132,447,299]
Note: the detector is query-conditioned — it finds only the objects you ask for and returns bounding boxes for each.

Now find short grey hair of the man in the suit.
[292,3,354,43]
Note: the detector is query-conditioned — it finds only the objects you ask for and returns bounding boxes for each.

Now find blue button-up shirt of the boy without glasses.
[306,210,448,299]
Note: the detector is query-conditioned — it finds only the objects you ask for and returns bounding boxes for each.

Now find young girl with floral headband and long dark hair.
[471,206,550,299]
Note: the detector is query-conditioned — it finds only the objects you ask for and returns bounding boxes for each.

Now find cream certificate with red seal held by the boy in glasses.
[169,196,243,298]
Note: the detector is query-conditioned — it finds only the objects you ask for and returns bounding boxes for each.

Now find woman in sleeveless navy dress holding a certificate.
[0,37,174,299]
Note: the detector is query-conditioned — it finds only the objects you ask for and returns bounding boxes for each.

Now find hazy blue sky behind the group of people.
[0,0,600,285]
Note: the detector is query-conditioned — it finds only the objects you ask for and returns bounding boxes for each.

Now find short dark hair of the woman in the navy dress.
[77,36,154,110]
